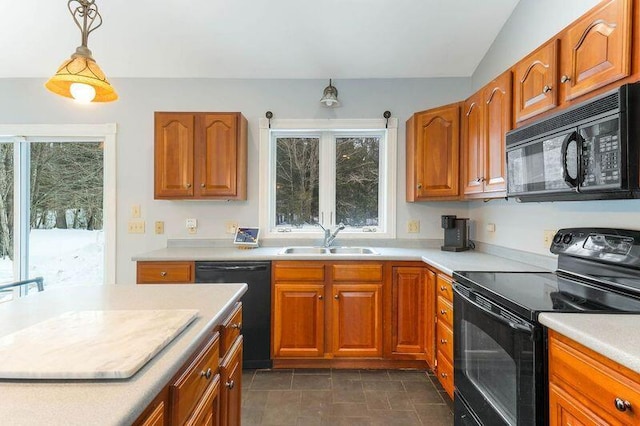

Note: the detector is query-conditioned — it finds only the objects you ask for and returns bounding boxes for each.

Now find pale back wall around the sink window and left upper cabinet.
[0,78,471,283]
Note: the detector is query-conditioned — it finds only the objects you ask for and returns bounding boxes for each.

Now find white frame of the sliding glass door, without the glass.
[0,123,117,284]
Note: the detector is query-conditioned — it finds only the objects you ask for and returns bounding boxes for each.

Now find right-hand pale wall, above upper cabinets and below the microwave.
[468,0,640,254]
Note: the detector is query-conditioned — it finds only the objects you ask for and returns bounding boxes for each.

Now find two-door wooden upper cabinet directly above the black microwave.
[513,0,632,123]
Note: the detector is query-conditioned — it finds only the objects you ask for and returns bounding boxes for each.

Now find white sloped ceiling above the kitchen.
[0,0,519,79]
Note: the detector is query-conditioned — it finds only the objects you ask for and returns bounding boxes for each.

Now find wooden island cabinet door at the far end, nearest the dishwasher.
[220,336,242,426]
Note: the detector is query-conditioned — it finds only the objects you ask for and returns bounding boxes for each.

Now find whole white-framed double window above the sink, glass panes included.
[260,120,397,238]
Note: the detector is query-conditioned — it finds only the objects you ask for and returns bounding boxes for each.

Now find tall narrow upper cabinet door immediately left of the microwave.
[482,71,512,196]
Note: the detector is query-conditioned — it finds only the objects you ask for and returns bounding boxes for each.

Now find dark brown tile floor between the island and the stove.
[242,369,453,426]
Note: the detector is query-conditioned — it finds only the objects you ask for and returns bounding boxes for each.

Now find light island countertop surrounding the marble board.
[0,284,247,425]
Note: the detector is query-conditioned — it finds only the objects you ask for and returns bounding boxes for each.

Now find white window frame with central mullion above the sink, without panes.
[259,118,398,240]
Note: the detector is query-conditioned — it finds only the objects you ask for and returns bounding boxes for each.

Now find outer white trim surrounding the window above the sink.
[258,118,398,239]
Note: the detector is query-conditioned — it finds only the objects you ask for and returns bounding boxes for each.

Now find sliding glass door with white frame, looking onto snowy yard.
[0,125,115,296]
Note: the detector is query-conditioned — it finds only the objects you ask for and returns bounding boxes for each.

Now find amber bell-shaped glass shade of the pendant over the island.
[45,53,118,102]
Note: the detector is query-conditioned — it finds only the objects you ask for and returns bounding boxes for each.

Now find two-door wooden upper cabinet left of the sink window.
[154,112,247,200]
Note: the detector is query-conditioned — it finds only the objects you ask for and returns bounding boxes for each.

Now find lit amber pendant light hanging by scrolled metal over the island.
[45,0,118,103]
